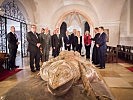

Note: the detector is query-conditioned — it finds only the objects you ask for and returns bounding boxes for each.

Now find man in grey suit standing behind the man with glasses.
[40,27,51,62]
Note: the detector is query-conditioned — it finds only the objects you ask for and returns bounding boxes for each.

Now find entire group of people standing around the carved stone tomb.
[7,25,106,72]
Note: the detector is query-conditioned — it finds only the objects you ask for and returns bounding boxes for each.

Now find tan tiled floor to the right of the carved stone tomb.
[99,63,133,100]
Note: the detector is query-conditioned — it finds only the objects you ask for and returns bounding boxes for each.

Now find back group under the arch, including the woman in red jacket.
[63,29,91,59]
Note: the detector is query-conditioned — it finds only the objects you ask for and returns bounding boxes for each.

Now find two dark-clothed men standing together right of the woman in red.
[92,27,107,69]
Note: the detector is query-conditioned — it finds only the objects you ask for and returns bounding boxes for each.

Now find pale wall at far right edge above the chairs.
[119,0,133,46]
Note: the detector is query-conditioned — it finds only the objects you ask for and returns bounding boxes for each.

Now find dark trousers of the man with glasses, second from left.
[30,49,41,70]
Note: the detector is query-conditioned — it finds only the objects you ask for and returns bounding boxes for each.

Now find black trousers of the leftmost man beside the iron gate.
[9,48,17,69]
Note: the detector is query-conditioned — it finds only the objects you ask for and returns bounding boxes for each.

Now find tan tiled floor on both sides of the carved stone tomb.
[0,57,133,100]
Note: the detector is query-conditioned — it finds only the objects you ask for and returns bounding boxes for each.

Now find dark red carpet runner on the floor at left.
[0,68,22,81]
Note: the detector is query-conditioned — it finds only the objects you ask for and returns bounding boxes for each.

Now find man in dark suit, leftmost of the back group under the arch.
[64,31,71,51]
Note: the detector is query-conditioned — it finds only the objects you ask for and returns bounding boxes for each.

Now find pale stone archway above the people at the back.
[51,5,99,36]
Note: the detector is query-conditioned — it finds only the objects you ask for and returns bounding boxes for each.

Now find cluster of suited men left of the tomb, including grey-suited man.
[27,25,62,72]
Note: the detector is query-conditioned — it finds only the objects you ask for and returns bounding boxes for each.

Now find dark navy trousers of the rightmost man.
[98,47,106,68]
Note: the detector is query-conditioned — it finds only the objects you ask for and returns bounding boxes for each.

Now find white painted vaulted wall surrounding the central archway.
[0,0,130,46]
